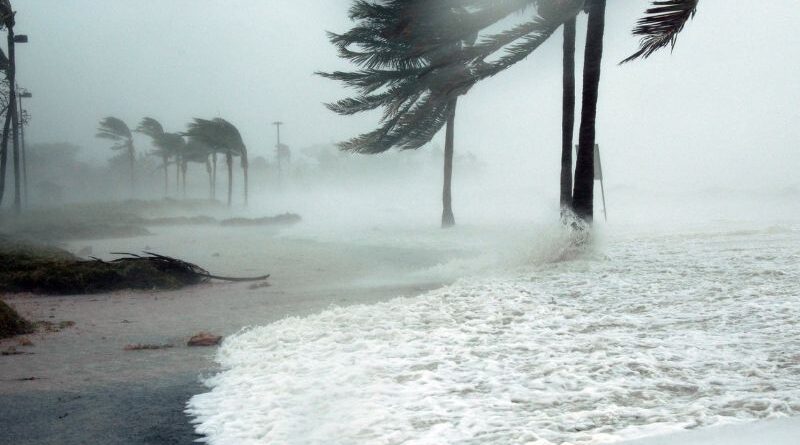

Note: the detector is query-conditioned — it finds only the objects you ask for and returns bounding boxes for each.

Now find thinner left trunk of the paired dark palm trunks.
[560,18,575,218]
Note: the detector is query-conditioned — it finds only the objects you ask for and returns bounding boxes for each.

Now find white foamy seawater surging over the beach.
[188,224,800,445]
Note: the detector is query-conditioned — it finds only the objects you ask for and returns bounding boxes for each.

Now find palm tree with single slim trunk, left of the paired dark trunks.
[318,0,484,227]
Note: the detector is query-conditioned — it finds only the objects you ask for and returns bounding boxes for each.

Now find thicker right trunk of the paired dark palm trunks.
[572,0,606,223]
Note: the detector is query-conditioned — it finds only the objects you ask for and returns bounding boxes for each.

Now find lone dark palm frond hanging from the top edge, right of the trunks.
[620,0,700,63]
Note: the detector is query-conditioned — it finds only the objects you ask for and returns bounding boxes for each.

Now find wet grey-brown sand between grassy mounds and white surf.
[0,227,452,444]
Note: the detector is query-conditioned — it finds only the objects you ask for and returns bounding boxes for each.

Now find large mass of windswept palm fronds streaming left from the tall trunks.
[318,0,584,153]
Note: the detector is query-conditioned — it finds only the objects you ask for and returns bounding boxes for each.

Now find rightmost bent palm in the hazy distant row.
[186,118,248,206]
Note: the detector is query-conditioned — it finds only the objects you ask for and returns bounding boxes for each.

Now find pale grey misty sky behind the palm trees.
[14,0,800,193]
